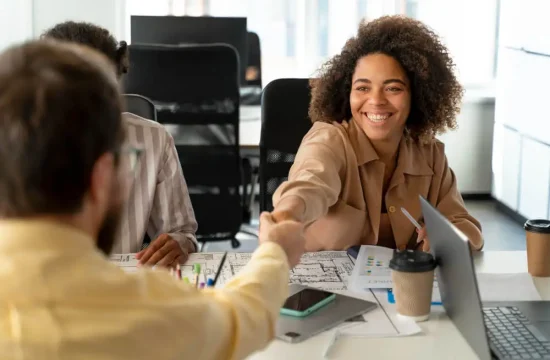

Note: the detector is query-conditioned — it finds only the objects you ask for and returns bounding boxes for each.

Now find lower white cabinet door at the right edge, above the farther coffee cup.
[518,137,550,219]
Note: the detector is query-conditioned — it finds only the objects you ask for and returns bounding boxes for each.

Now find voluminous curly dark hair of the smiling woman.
[309,16,463,140]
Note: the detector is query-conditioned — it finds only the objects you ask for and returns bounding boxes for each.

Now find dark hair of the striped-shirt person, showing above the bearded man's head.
[41,21,129,76]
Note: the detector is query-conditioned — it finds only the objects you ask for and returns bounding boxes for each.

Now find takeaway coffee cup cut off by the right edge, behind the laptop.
[524,220,550,277]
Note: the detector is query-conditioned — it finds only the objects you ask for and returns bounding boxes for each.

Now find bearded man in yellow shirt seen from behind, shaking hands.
[0,41,304,360]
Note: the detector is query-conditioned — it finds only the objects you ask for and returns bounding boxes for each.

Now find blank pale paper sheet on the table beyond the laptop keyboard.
[476,273,541,301]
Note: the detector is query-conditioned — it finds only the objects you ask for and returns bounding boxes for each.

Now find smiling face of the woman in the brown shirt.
[349,54,411,141]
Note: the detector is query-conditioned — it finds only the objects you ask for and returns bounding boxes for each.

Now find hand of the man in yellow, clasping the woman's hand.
[259,212,305,268]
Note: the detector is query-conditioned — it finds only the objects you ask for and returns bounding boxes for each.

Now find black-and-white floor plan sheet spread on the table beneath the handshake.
[111,251,353,291]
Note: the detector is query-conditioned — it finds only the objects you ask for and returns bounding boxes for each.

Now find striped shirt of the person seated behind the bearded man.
[112,113,197,254]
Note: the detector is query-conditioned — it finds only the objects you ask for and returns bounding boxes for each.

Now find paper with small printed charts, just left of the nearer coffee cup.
[349,245,393,292]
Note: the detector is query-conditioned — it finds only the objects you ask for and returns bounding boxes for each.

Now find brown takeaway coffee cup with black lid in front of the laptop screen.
[390,250,436,322]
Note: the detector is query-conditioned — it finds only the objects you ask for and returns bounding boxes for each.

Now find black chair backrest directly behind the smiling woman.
[260,79,312,211]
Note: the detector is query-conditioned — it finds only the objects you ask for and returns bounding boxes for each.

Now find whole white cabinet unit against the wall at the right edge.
[492,0,550,219]
